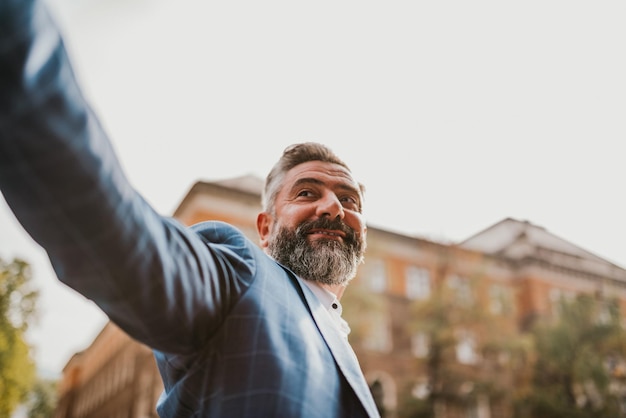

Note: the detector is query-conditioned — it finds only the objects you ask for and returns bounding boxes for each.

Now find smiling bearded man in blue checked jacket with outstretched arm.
[0,0,378,418]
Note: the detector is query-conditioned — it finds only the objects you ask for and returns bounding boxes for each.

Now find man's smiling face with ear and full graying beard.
[259,161,367,285]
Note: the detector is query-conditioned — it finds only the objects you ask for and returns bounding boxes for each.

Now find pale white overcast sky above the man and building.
[0,0,626,373]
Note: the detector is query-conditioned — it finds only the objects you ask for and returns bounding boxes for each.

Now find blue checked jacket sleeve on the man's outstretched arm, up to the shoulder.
[0,0,254,353]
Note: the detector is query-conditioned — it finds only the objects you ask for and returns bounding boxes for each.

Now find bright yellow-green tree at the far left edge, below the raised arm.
[0,258,38,417]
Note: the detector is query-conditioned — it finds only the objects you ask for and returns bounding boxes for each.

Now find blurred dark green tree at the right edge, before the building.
[519,295,626,418]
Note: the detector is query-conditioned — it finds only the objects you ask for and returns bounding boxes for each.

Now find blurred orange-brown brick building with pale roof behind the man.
[55,177,626,418]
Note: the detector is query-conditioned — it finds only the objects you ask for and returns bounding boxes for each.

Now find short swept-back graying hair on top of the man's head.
[261,142,365,214]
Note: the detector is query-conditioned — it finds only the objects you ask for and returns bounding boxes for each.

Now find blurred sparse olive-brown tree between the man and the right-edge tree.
[400,274,532,418]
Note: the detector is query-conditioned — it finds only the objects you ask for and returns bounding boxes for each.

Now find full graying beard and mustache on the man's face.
[268,218,365,286]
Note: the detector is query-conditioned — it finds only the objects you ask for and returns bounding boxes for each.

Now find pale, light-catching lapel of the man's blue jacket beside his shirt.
[292,273,379,416]
